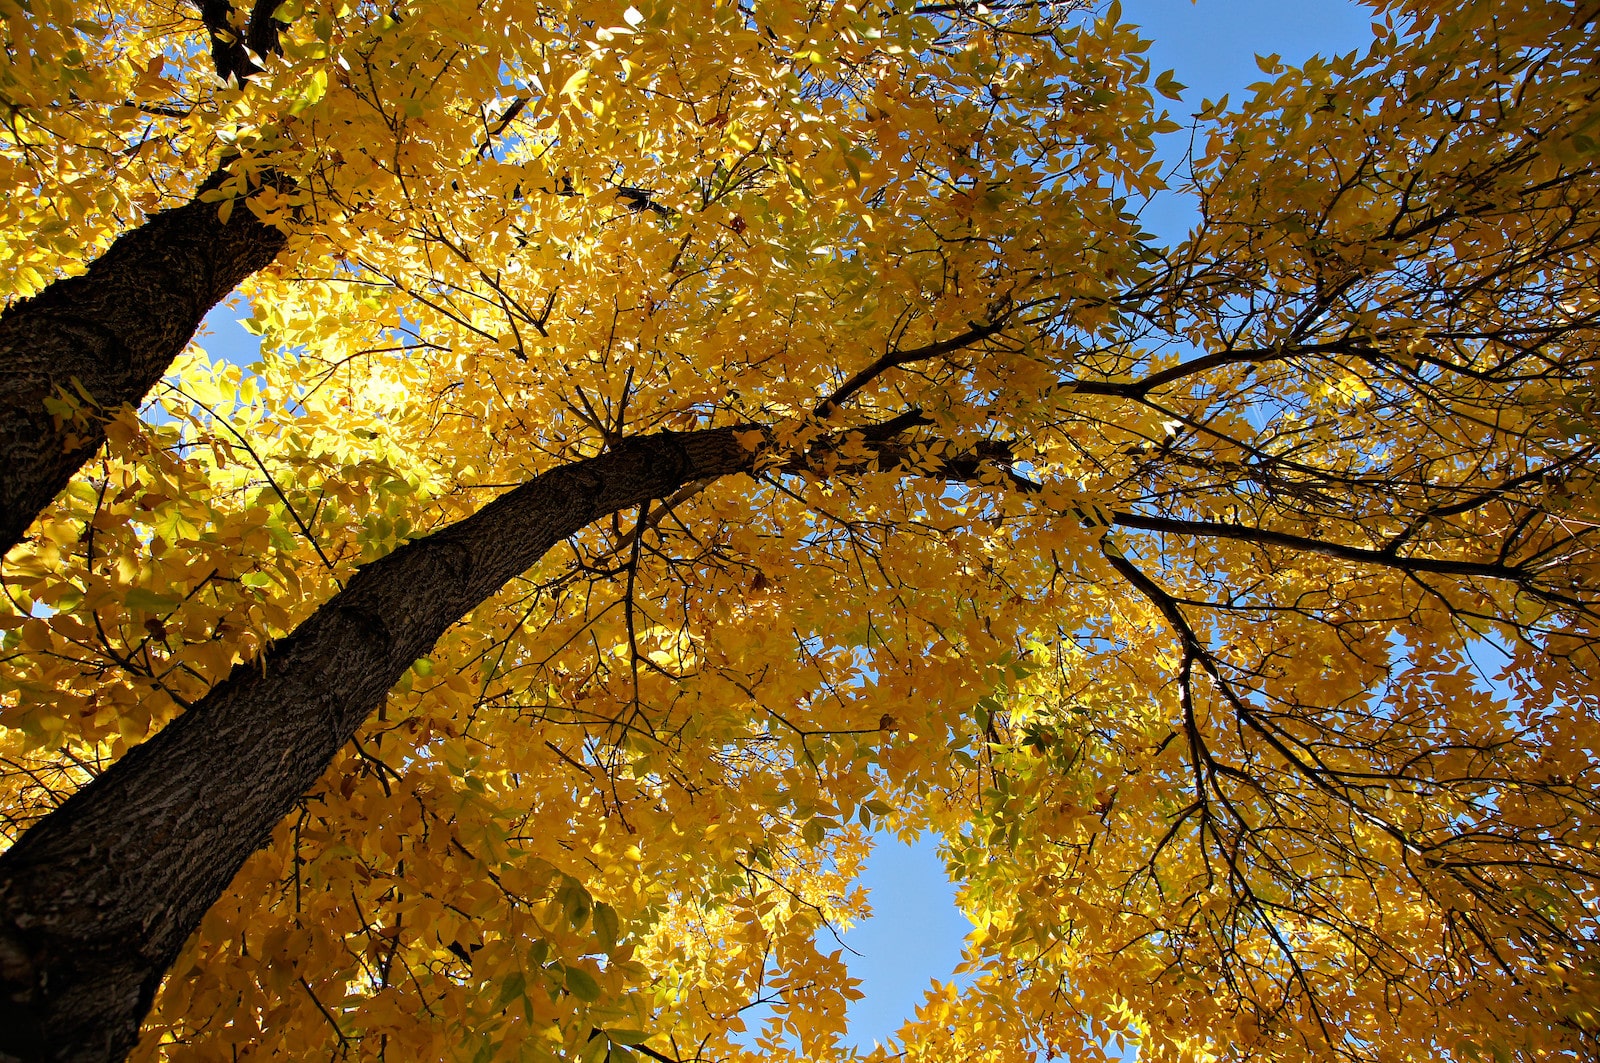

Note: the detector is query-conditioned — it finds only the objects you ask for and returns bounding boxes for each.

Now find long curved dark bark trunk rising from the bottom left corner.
[0,427,754,1063]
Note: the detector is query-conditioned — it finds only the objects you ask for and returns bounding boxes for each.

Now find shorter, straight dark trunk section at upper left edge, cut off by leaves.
[0,173,285,556]
